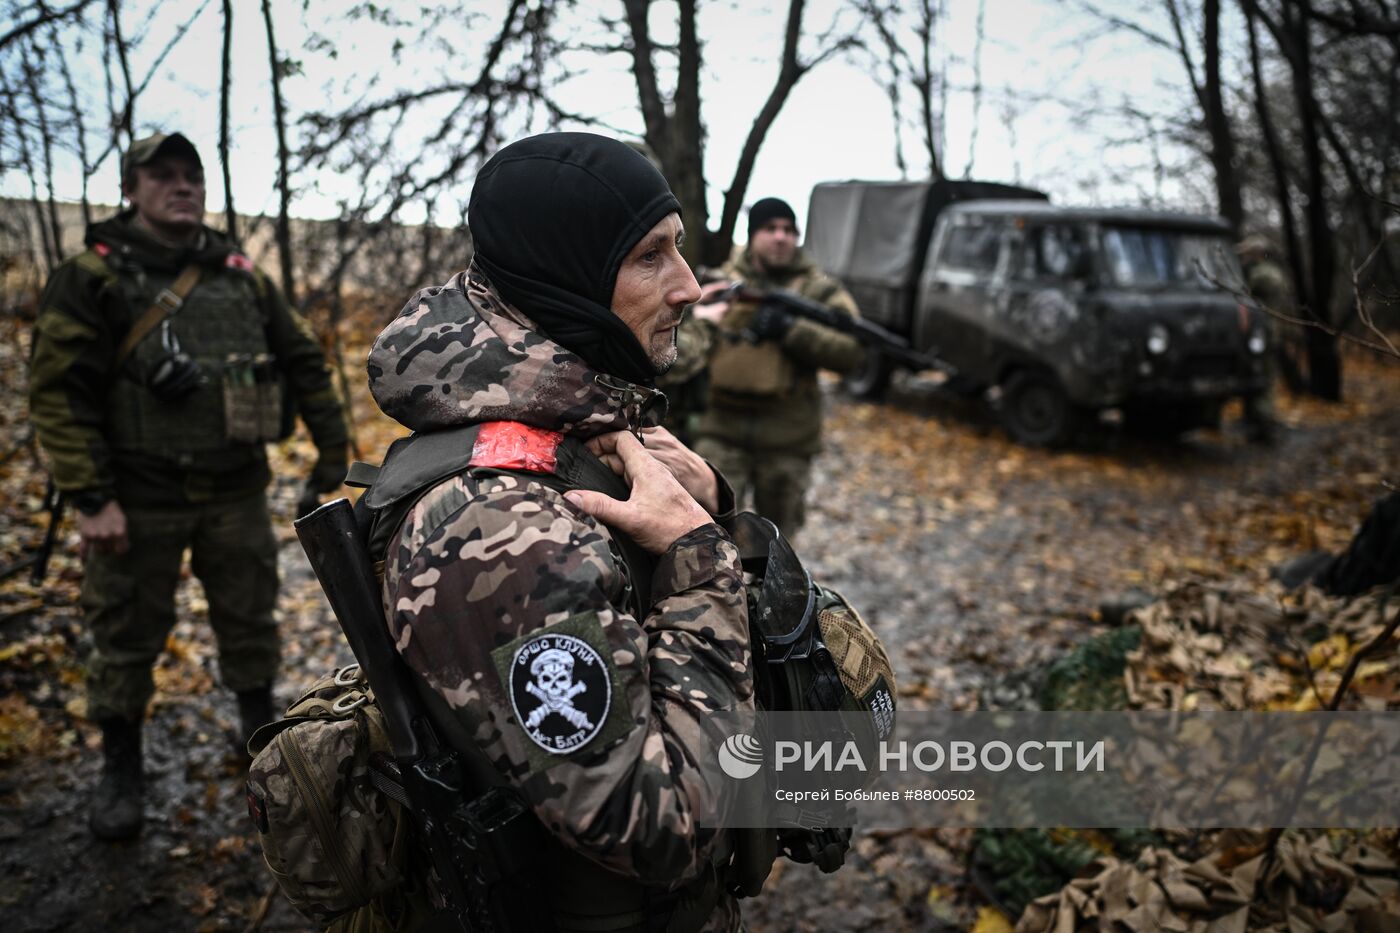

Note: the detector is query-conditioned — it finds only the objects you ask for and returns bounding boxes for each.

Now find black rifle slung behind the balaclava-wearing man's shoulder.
[295,499,553,933]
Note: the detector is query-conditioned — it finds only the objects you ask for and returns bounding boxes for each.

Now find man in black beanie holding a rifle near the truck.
[696,198,864,537]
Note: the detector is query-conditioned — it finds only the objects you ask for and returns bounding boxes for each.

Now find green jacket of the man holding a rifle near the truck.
[700,247,865,455]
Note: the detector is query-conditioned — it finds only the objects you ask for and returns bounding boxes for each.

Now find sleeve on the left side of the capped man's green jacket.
[29,251,121,496]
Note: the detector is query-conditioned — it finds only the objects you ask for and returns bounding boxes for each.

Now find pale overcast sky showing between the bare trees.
[0,0,1211,231]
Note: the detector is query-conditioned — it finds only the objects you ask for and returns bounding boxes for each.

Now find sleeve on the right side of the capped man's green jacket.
[253,269,349,461]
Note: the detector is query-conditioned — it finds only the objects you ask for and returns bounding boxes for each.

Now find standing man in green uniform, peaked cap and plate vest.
[29,133,347,839]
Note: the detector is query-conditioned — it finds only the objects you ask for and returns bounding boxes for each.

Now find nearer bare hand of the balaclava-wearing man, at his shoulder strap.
[564,431,711,553]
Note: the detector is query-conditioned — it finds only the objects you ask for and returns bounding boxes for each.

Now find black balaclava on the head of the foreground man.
[466,133,680,385]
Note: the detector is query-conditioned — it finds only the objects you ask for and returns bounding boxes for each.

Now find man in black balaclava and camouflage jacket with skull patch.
[368,133,753,932]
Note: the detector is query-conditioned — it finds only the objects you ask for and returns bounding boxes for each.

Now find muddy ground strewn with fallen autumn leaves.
[0,306,1400,932]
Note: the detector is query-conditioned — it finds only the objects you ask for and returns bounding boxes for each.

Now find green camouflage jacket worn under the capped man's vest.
[29,212,347,506]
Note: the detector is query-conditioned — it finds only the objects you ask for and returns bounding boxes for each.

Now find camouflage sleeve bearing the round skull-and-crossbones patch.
[385,475,753,887]
